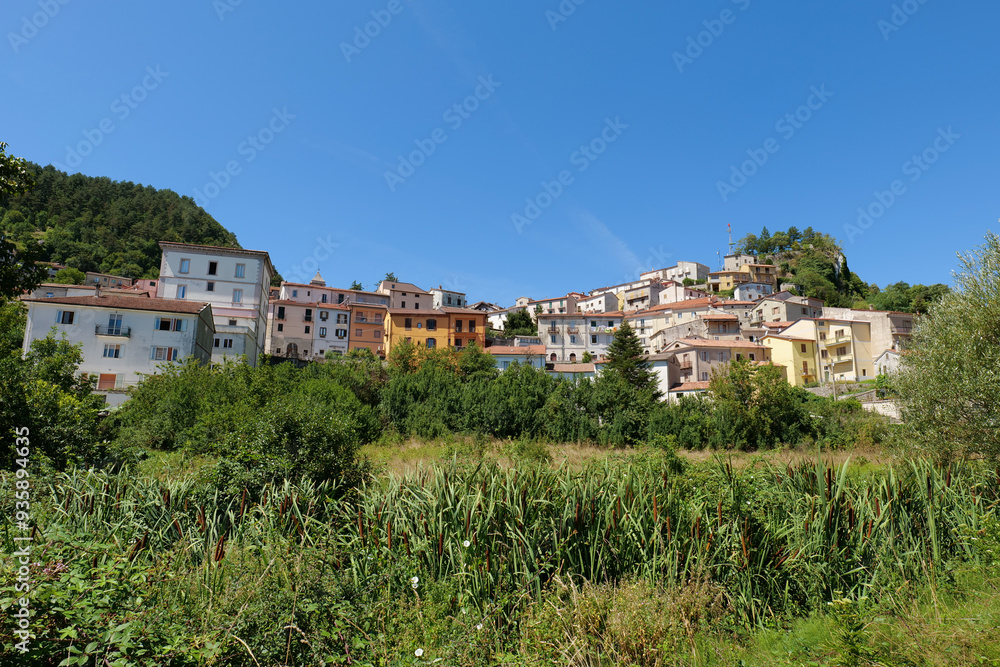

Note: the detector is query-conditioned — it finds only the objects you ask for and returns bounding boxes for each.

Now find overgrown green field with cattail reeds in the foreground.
[0,438,1000,667]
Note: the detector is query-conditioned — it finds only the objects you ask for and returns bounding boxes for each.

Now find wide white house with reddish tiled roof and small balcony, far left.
[23,292,215,405]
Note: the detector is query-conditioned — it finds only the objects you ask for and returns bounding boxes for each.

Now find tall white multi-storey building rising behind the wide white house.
[156,241,274,366]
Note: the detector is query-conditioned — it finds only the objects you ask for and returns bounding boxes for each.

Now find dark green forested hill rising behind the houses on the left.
[0,163,239,278]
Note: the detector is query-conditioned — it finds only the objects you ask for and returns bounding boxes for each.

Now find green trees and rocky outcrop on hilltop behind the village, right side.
[736,226,949,313]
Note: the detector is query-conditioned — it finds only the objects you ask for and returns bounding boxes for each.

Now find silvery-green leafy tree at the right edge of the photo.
[883,233,1000,462]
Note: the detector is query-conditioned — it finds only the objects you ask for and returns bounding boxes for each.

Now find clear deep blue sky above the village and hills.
[0,0,1000,304]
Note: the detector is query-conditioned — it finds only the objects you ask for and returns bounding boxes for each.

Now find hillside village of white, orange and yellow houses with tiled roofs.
[22,241,914,405]
